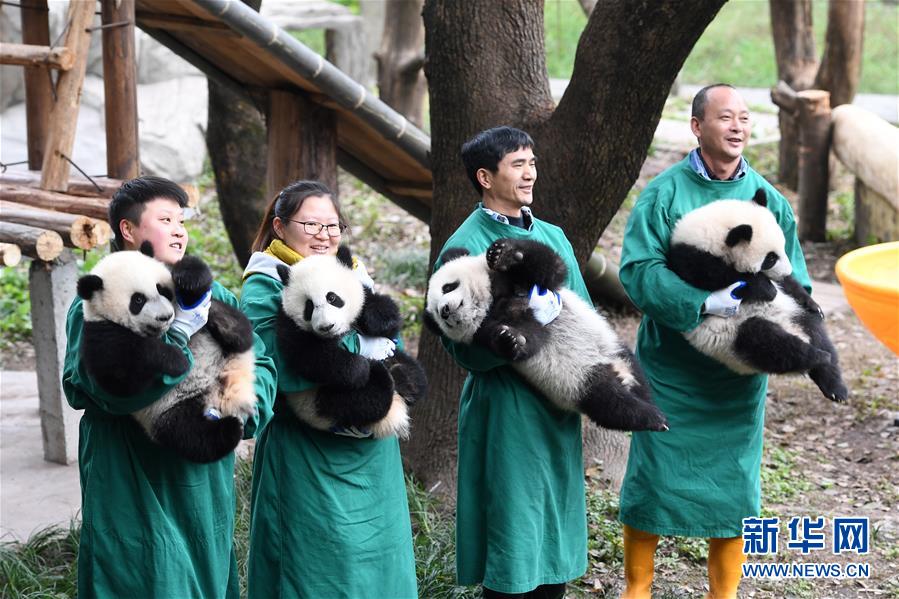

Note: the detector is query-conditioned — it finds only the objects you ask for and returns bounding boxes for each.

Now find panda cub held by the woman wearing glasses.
[277,246,427,439]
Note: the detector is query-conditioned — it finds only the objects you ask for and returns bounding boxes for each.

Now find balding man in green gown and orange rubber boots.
[620,84,811,599]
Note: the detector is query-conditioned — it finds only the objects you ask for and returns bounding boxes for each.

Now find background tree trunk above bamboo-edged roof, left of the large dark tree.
[375,0,427,128]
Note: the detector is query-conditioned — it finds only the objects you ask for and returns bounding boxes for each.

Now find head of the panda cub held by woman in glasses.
[281,256,365,337]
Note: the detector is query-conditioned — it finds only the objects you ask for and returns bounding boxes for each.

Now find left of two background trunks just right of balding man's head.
[769,0,818,191]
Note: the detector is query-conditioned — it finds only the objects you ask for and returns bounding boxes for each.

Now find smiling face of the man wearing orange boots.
[690,87,752,166]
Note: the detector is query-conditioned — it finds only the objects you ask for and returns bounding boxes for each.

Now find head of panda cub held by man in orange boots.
[671,189,793,280]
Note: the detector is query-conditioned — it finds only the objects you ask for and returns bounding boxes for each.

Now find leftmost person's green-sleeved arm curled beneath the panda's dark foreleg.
[62,298,194,415]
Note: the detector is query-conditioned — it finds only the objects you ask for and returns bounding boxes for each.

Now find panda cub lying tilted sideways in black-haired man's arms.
[425,239,668,431]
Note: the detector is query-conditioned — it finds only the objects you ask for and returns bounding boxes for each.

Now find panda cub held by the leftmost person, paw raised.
[78,243,256,463]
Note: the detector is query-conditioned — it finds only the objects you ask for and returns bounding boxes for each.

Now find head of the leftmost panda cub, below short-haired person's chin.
[78,251,175,337]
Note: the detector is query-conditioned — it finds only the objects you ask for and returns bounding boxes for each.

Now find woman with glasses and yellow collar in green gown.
[241,181,417,599]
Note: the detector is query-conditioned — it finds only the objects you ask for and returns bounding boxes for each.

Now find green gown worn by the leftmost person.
[63,283,276,599]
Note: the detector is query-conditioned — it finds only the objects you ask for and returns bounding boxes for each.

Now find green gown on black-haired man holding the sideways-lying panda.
[438,208,590,593]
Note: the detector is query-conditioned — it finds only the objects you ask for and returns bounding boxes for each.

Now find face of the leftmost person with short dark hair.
[119,198,188,266]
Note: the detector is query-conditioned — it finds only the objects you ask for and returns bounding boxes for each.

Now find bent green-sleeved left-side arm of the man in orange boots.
[619,189,709,331]
